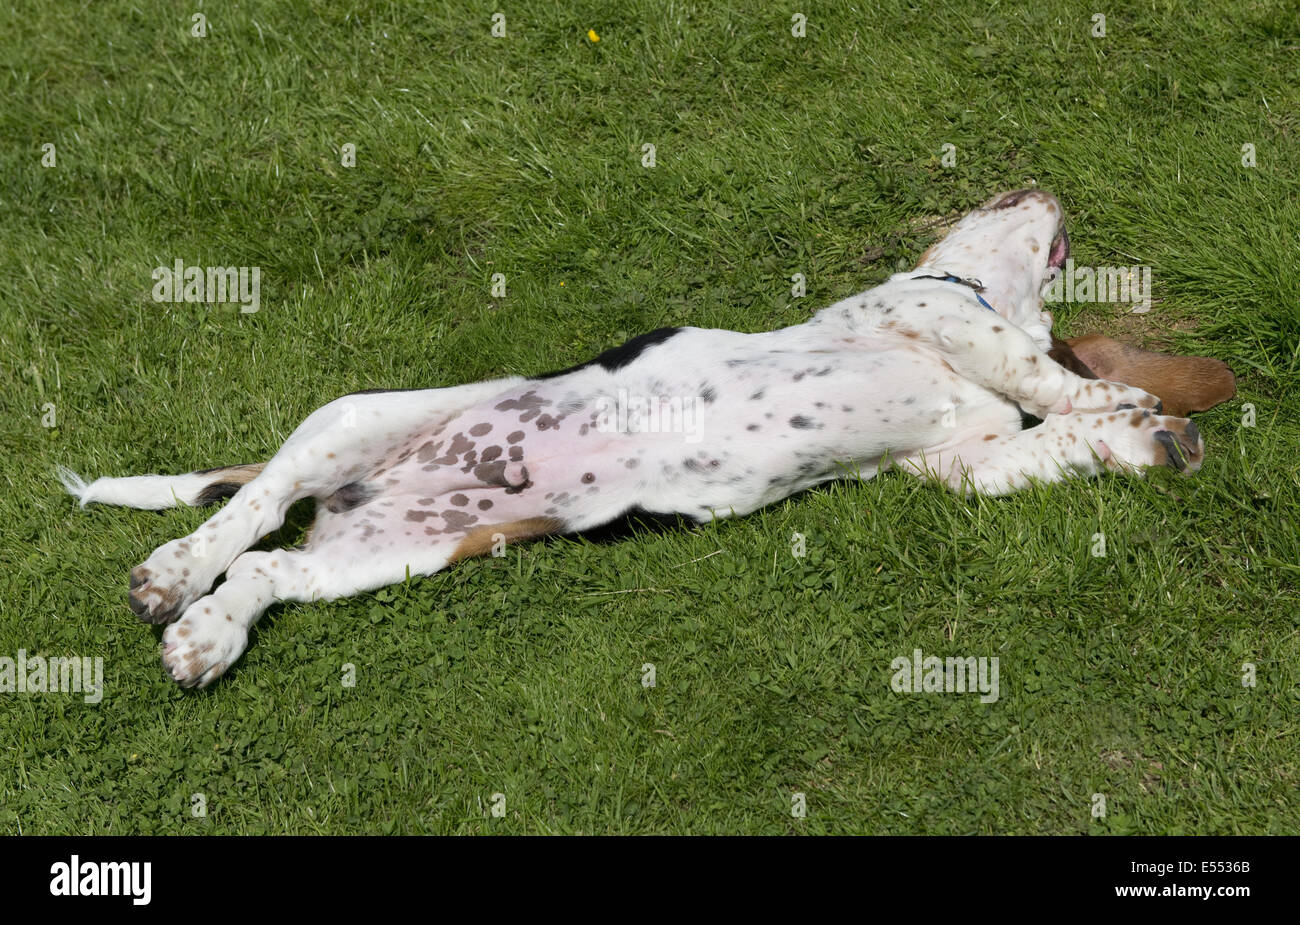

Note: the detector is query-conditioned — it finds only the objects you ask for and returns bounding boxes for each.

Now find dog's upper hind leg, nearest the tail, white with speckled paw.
[129,378,524,624]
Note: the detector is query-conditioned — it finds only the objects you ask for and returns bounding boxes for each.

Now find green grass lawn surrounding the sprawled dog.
[0,0,1300,833]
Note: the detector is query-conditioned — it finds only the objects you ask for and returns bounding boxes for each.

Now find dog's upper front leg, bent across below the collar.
[879,299,1160,417]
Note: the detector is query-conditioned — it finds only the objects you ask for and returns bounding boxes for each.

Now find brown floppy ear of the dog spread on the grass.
[1052,334,1236,417]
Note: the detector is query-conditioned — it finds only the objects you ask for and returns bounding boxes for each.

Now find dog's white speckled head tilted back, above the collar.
[907,190,1070,343]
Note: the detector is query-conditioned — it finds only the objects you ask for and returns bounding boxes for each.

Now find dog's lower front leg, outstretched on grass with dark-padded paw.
[897,409,1205,495]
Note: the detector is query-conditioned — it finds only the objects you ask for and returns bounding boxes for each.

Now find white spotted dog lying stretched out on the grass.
[59,190,1231,687]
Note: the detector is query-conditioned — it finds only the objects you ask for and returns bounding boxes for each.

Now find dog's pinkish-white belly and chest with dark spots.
[361,329,1019,534]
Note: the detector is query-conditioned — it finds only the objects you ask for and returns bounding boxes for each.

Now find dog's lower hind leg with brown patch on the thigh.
[163,517,563,687]
